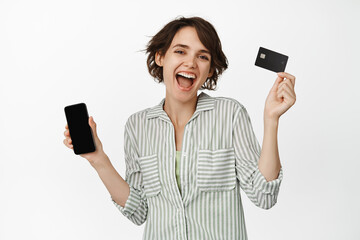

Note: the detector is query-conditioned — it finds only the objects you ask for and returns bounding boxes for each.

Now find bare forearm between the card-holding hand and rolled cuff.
[258,118,281,181]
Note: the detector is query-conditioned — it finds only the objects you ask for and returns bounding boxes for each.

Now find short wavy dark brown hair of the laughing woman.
[146,17,228,90]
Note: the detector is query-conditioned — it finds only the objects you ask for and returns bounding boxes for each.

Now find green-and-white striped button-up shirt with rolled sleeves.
[113,92,283,240]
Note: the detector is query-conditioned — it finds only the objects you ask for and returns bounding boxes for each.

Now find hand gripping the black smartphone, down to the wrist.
[64,117,109,167]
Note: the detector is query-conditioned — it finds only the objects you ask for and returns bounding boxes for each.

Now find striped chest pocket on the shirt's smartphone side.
[139,154,161,198]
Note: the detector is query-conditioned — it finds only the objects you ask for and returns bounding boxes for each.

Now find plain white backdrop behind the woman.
[0,0,360,240]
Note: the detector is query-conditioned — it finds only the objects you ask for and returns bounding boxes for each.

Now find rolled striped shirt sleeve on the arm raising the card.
[233,106,283,209]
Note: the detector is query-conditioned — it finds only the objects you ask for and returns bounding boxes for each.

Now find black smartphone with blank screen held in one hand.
[64,103,95,155]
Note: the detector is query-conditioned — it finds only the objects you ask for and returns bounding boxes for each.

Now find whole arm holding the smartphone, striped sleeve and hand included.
[64,117,147,225]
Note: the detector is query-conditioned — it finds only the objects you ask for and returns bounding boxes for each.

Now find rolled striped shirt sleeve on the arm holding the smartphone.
[111,121,148,225]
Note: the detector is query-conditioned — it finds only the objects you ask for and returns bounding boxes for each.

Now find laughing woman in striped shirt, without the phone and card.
[64,17,296,240]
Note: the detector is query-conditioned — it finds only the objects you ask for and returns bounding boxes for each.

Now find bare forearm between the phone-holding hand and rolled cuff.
[93,155,130,207]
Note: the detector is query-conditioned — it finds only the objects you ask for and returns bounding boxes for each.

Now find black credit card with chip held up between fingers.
[255,47,289,73]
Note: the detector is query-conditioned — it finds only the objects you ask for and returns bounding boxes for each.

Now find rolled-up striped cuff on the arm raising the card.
[253,167,283,195]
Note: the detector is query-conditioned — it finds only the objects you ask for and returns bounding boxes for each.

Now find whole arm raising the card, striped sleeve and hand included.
[234,72,296,209]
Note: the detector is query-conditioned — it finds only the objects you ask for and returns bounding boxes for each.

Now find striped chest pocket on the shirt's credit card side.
[196,148,236,191]
